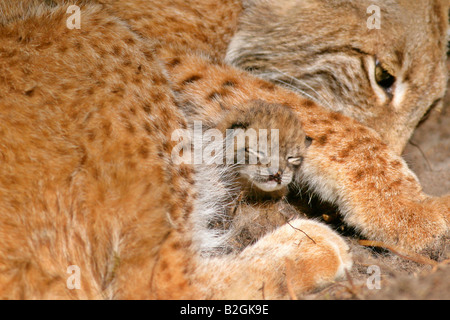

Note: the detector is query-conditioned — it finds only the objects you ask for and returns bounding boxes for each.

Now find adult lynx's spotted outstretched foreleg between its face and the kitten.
[166,50,450,250]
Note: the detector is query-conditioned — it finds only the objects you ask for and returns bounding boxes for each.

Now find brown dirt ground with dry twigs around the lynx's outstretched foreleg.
[302,59,450,300]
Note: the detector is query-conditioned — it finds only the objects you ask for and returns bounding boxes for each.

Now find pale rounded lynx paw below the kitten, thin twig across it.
[223,219,352,299]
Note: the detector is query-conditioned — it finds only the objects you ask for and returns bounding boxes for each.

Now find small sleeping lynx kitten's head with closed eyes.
[221,101,311,193]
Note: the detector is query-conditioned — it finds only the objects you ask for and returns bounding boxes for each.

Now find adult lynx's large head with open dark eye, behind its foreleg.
[227,0,448,153]
